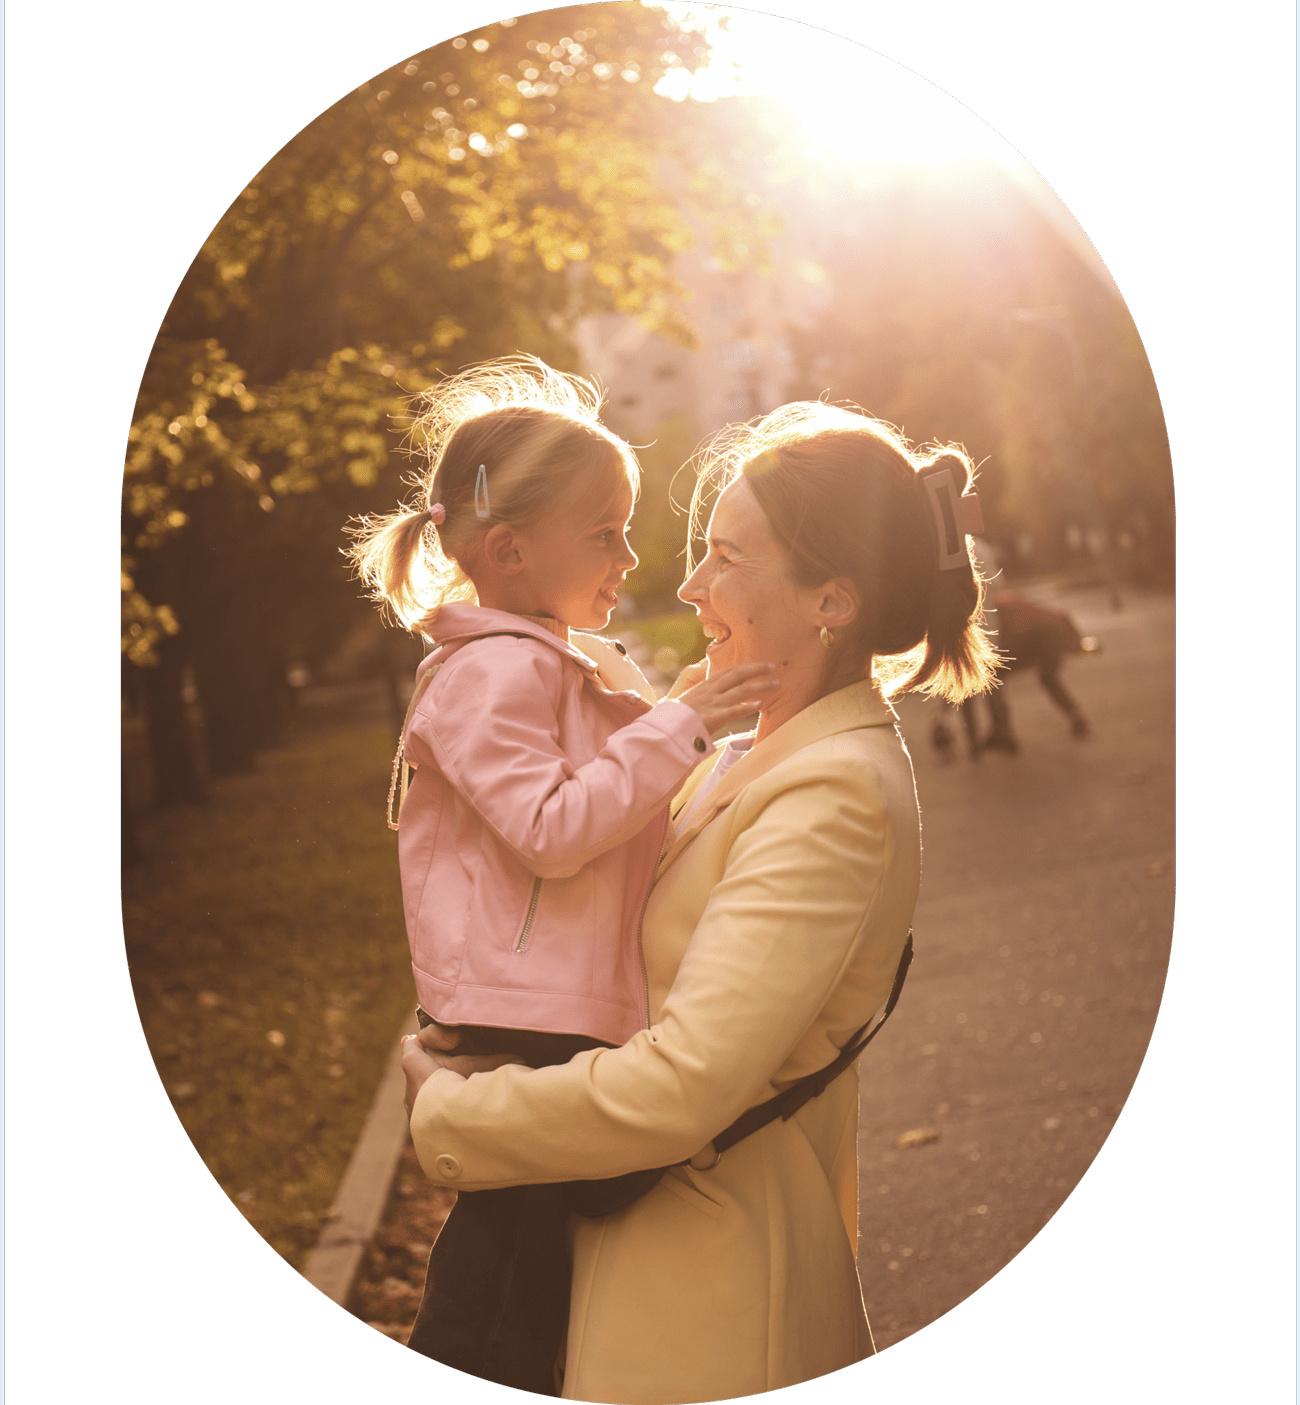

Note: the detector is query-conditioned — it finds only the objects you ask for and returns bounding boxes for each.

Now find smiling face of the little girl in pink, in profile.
[517,471,637,629]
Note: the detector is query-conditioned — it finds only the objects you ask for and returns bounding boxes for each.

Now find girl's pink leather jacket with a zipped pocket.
[398,606,713,1044]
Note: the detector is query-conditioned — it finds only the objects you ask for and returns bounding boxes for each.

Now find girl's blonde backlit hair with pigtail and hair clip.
[347,355,641,632]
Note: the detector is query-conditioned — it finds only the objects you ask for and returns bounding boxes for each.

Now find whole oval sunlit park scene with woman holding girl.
[119,0,1175,1382]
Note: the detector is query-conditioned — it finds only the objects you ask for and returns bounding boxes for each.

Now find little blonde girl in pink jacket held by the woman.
[344,357,777,1394]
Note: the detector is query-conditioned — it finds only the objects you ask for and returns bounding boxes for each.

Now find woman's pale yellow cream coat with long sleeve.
[412,683,921,1405]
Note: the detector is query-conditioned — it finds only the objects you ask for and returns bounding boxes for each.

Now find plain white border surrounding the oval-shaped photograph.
[6,0,1296,1405]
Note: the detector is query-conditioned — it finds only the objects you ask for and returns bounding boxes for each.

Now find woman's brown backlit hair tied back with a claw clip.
[687,400,996,703]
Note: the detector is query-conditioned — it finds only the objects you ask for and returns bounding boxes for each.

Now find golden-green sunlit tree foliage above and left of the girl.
[124,3,762,663]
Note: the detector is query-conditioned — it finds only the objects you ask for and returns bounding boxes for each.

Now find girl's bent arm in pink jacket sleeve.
[406,636,713,878]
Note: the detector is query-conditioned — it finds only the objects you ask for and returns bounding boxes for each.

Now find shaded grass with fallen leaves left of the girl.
[122,726,415,1267]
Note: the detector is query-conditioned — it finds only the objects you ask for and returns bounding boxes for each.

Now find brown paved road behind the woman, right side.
[860,581,1174,1349]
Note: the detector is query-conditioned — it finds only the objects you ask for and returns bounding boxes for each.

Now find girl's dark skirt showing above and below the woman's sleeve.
[406,1010,611,1395]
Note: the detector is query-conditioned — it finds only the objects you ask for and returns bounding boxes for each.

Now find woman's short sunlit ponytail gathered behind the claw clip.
[902,448,998,704]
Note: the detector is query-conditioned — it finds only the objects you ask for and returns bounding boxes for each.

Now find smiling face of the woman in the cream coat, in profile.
[677,478,825,685]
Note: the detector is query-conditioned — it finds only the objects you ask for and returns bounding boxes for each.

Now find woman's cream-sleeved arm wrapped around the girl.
[412,756,906,1187]
